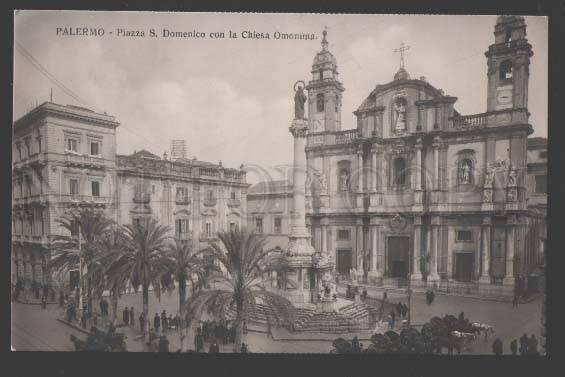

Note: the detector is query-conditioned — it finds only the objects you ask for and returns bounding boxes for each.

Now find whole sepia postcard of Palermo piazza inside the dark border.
[10,10,549,356]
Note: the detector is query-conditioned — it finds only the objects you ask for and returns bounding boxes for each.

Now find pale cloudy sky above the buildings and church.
[14,11,548,182]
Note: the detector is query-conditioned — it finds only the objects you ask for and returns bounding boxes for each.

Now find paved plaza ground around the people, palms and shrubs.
[12,292,541,354]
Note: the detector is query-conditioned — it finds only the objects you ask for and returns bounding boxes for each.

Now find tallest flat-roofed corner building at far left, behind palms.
[12,102,119,284]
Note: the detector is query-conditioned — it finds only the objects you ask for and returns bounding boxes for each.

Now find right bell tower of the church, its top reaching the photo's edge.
[485,16,534,111]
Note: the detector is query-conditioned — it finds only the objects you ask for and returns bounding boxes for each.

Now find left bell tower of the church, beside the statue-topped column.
[306,30,345,132]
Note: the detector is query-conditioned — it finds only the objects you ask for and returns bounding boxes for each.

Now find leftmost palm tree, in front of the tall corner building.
[47,207,112,314]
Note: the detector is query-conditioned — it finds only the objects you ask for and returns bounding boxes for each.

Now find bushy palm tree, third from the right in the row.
[106,219,169,335]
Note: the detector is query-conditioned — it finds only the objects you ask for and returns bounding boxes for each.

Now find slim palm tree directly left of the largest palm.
[161,239,207,351]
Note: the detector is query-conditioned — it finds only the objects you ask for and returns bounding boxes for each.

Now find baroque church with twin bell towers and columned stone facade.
[306,16,546,294]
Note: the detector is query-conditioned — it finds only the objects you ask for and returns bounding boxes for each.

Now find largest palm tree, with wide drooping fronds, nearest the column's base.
[187,230,294,352]
